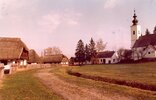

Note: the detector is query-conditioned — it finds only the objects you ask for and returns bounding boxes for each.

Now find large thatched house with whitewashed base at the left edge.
[0,37,29,68]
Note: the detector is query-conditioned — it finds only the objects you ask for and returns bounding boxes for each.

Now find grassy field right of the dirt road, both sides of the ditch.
[51,63,156,100]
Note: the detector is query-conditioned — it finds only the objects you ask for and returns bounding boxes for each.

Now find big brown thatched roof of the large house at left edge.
[0,37,28,60]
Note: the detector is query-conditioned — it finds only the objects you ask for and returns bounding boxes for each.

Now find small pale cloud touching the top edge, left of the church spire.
[104,0,120,9]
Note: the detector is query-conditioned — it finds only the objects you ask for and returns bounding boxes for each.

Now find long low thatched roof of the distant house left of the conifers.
[43,54,64,63]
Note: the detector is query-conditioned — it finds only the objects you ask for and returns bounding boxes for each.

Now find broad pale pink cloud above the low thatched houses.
[38,11,81,33]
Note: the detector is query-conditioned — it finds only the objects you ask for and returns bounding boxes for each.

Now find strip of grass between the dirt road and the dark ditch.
[51,66,156,100]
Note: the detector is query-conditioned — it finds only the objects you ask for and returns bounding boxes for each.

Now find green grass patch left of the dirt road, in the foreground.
[0,70,60,100]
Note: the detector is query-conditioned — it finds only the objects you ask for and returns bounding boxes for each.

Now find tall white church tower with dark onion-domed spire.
[131,10,141,48]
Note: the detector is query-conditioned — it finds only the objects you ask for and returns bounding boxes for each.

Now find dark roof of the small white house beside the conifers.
[97,51,115,58]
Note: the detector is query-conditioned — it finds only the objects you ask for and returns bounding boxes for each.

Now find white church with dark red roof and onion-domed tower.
[131,11,156,60]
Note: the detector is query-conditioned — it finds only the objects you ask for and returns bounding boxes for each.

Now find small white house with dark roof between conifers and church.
[97,51,119,64]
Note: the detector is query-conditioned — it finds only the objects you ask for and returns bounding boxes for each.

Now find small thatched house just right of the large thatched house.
[28,49,41,64]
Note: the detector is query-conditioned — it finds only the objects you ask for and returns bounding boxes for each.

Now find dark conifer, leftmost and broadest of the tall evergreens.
[75,40,85,65]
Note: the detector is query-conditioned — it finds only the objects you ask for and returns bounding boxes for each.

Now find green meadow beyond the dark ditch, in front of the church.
[72,63,156,85]
